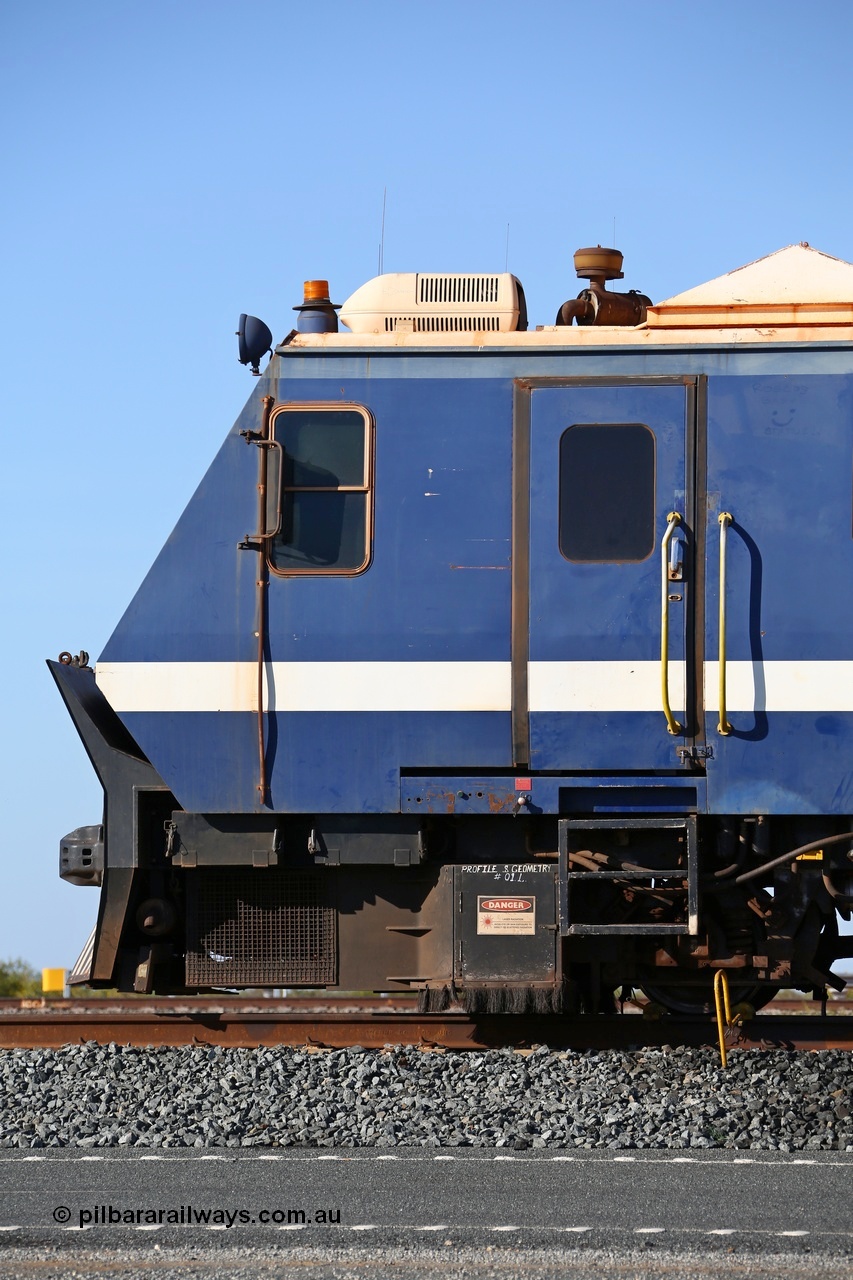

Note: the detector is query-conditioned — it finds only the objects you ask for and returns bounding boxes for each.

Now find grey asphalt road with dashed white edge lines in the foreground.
[0,1149,853,1280]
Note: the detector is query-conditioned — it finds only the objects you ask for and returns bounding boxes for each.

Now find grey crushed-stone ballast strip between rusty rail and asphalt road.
[0,1043,853,1152]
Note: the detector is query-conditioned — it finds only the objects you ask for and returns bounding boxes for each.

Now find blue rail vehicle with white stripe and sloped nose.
[50,244,853,1014]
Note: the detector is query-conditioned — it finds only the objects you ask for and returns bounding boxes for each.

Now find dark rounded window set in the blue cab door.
[560,422,654,563]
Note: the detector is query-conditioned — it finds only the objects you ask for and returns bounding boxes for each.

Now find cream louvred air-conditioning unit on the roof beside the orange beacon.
[341,271,528,333]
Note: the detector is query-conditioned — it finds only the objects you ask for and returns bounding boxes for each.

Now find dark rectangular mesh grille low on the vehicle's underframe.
[186,868,337,987]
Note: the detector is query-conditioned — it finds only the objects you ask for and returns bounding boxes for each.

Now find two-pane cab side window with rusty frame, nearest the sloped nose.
[268,404,373,573]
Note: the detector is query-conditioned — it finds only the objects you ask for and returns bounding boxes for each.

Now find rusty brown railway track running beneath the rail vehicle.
[0,996,853,1051]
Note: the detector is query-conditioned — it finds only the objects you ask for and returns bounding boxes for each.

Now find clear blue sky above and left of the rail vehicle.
[0,0,853,966]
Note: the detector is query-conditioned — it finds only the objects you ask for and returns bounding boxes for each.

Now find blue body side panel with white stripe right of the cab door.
[704,371,853,815]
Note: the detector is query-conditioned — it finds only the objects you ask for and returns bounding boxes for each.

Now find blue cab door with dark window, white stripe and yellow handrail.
[526,379,695,773]
